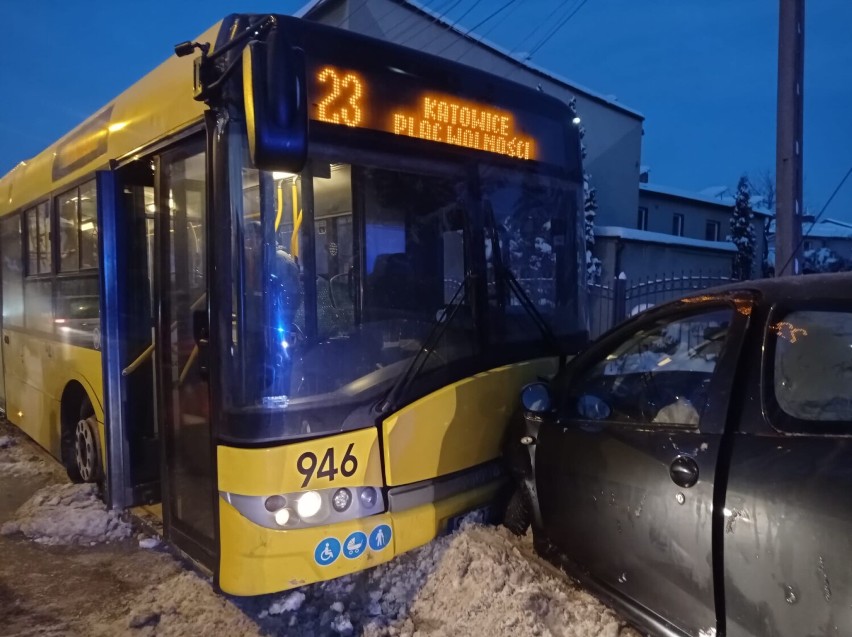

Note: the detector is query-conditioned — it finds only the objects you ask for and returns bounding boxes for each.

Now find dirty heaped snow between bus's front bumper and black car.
[245,525,638,637]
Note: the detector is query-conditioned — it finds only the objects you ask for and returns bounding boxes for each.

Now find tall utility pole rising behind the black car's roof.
[775,0,805,276]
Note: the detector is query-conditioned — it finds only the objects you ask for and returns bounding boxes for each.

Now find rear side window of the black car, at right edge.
[769,310,852,433]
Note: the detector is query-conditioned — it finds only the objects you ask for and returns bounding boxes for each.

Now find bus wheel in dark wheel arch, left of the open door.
[60,381,102,482]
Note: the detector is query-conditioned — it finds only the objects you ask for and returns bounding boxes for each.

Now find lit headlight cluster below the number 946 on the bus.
[225,486,385,531]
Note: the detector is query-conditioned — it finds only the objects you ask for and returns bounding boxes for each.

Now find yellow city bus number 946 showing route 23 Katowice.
[0,15,587,595]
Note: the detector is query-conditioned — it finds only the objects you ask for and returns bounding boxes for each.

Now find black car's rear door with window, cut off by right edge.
[722,304,852,637]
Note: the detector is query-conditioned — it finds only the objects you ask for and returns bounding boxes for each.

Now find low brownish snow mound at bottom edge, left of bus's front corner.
[97,572,260,637]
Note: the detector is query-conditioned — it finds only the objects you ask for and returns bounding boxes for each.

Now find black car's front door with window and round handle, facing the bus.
[535,297,750,635]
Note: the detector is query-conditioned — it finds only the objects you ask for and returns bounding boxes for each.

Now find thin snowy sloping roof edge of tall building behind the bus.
[293,0,645,120]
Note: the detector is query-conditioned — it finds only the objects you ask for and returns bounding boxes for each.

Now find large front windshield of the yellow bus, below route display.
[223,137,583,437]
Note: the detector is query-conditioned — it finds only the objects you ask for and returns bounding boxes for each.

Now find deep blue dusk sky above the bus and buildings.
[0,0,852,221]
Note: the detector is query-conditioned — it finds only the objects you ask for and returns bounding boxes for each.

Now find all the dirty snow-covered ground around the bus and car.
[0,428,638,637]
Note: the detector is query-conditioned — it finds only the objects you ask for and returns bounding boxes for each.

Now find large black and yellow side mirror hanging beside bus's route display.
[243,29,308,173]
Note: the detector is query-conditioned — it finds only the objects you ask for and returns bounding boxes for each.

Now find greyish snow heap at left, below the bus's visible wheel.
[0,484,131,544]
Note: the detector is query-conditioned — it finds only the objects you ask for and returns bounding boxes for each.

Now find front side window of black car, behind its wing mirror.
[565,307,733,427]
